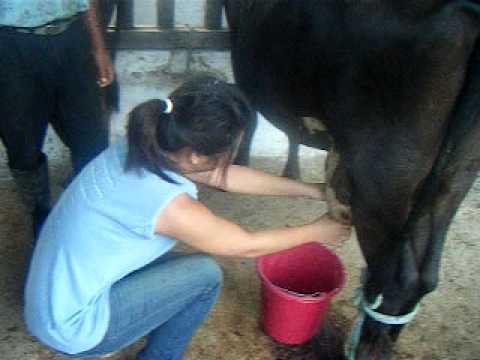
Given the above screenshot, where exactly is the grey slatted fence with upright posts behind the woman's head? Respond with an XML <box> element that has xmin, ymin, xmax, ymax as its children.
<box><xmin>99</xmin><ymin>0</ymin><xmax>229</xmax><ymax>50</ymax></box>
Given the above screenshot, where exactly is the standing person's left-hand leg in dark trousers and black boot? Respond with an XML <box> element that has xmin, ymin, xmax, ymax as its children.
<box><xmin>0</xmin><ymin>30</ymin><xmax>50</xmax><ymax>236</ymax></box>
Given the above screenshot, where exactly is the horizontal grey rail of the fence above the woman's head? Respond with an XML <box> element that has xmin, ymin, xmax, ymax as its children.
<box><xmin>107</xmin><ymin>28</ymin><xmax>230</xmax><ymax>50</ymax></box>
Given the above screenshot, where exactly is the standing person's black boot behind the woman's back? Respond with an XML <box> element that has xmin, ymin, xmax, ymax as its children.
<box><xmin>10</xmin><ymin>156</ymin><xmax>50</xmax><ymax>239</ymax></box>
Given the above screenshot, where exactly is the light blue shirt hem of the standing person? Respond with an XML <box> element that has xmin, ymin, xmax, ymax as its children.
<box><xmin>0</xmin><ymin>0</ymin><xmax>89</xmax><ymax>27</ymax></box>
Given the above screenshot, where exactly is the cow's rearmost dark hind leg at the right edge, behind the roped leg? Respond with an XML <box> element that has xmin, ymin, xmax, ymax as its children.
<box><xmin>391</xmin><ymin>35</ymin><xmax>480</xmax><ymax>339</ymax></box>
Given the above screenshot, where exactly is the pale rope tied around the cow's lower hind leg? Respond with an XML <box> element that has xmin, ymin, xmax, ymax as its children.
<box><xmin>345</xmin><ymin>288</ymin><xmax>420</xmax><ymax>360</ymax></box>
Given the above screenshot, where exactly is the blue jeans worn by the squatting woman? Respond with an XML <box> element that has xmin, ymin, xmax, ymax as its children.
<box><xmin>74</xmin><ymin>252</ymin><xmax>222</xmax><ymax>360</ymax></box>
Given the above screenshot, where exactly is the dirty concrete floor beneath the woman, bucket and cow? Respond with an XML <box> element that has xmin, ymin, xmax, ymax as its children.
<box><xmin>0</xmin><ymin>144</ymin><xmax>480</xmax><ymax>360</ymax></box>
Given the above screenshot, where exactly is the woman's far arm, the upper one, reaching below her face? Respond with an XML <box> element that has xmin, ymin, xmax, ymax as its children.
<box><xmin>185</xmin><ymin>165</ymin><xmax>325</xmax><ymax>200</ymax></box>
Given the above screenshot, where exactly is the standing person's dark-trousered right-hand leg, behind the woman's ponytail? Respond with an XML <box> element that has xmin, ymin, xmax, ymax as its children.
<box><xmin>51</xmin><ymin>19</ymin><xmax>109</xmax><ymax>174</ymax></box>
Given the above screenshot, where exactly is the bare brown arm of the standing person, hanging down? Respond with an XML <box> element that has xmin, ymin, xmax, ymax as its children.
<box><xmin>85</xmin><ymin>0</ymin><xmax>115</xmax><ymax>87</ymax></box>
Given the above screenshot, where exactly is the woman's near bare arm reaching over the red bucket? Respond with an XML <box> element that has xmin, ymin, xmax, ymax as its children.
<box><xmin>155</xmin><ymin>194</ymin><xmax>350</xmax><ymax>257</ymax></box>
